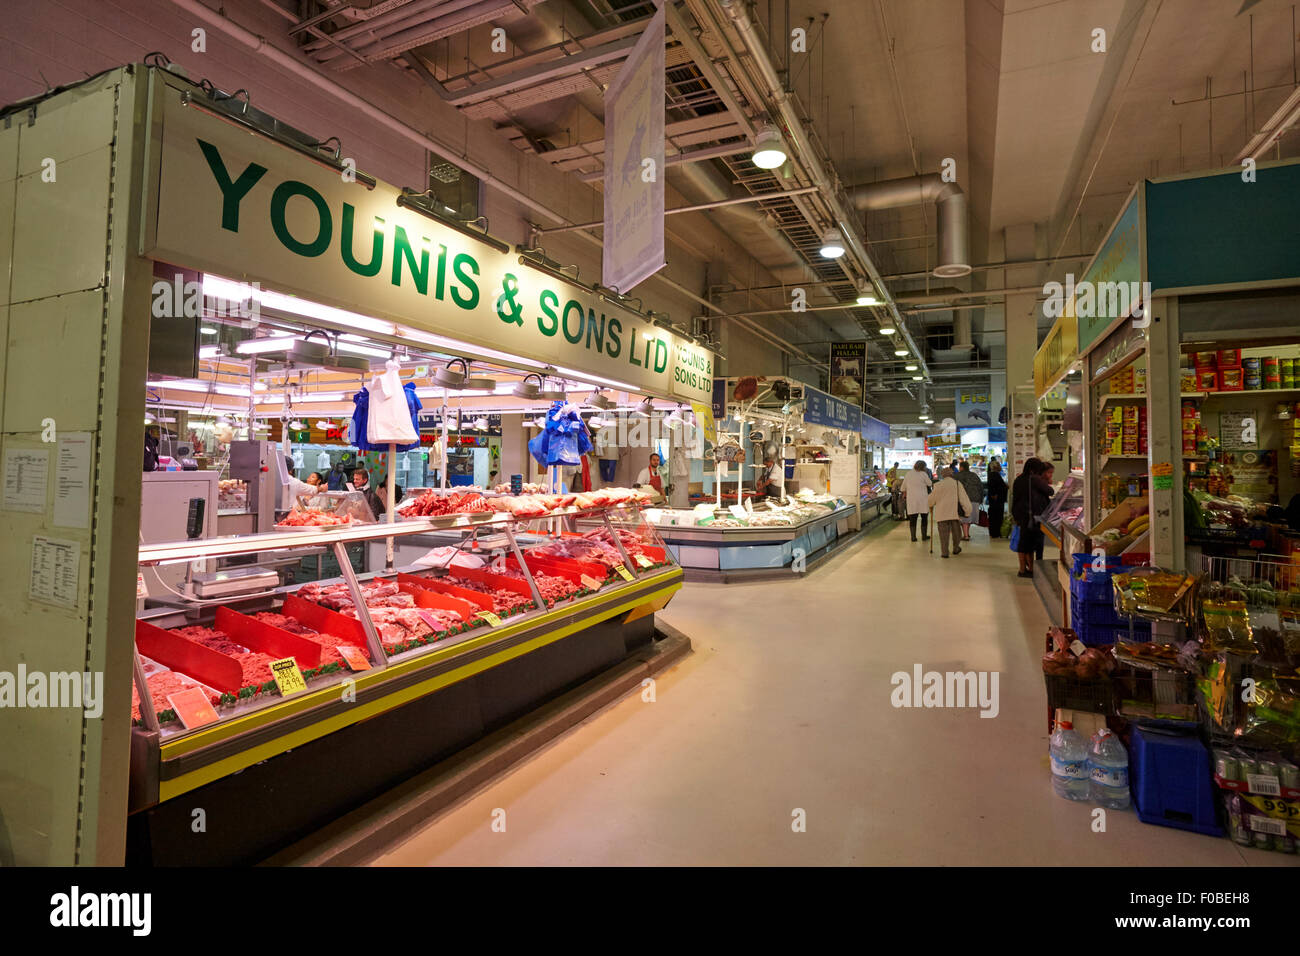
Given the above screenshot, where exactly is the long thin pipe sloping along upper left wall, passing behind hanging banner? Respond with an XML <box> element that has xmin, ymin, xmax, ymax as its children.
<box><xmin>172</xmin><ymin>0</ymin><xmax>824</xmax><ymax>364</ymax></box>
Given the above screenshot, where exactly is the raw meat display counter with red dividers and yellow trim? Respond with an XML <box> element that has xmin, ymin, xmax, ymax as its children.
<box><xmin>127</xmin><ymin>501</ymin><xmax>683</xmax><ymax>865</ymax></box>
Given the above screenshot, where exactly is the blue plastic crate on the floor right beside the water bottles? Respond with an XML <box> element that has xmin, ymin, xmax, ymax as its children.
<box><xmin>1128</xmin><ymin>727</ymin><xmax>1223</xmax><ymax>836</ymax></box>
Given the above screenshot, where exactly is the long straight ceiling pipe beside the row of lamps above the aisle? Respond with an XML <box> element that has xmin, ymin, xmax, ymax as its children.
<box><xmin>716</xmin><ymin>0</ymin><xmax>928</xmax><ymax>375</ymax></box>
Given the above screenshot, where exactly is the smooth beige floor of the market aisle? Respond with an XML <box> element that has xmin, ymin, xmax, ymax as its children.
<box><xmin>376</xmin><ymin>523</ymin><xmax>1294</xmax><ymax>866</ymax></box>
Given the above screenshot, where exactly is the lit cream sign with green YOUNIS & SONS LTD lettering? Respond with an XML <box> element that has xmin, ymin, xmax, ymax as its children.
<box><xmin>140</xmin><ymin>83</ymin><xmax>714</xmax><ymax>402</ymax></box>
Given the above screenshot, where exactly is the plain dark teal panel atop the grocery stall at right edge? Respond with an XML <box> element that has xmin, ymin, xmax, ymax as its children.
<box><xmin>1147</xmin><ymin>164</ymin><xmax>1300</xmax><ymax>293</ymax></box>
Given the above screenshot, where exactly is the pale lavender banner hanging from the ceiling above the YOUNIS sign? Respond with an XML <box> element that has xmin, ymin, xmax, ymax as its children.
<box><xmin>601</xmin><ymin>9</ymin><xmax>667</xmax><ymax>294</ymax></box>
